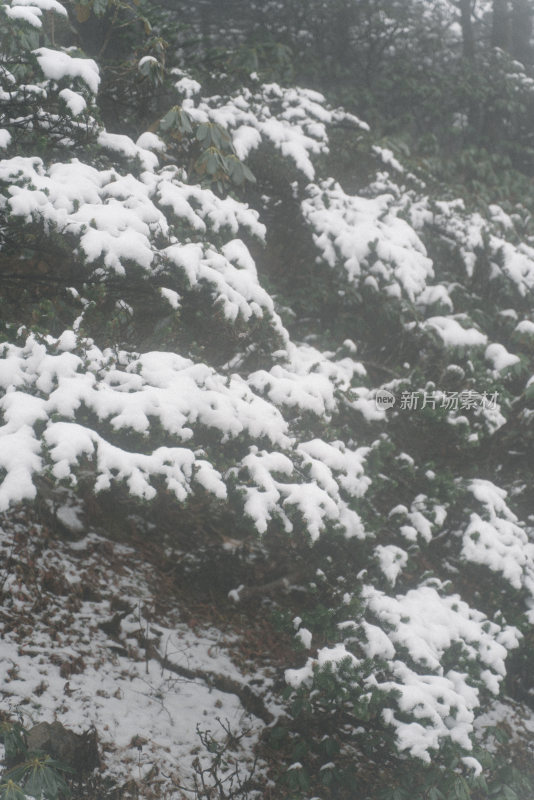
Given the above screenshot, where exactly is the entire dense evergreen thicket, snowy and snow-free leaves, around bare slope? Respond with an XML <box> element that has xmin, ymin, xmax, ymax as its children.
<box><xmin>0</xmin><ymin>0</ymin><xmax>534</xmax><ymax>800</ymax></box>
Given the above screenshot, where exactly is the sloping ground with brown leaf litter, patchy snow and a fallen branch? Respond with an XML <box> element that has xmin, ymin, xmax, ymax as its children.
<box><xmin>0</xmin><ymin>504</ymin><xmax>296</xmax><ymax>798</ymax></box>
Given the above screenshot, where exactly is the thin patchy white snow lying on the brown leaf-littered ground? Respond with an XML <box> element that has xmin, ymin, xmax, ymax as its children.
<box><xmin>0</xmin><ymin>523</ymin><xmax>275</xmax><ymax>791</ymax></box>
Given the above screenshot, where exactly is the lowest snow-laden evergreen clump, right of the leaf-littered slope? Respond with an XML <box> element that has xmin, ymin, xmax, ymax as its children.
<box><xmin>292</xmin><ymin>585</ymin><xmax>518</xmax><ymax>762</ymax></box>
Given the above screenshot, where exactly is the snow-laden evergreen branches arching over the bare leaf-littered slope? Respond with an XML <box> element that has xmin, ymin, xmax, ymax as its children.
<box><xmin>0</xmin><ymin>0</ymin><xmax>534</xmax><ymax>792</ymax></box>
